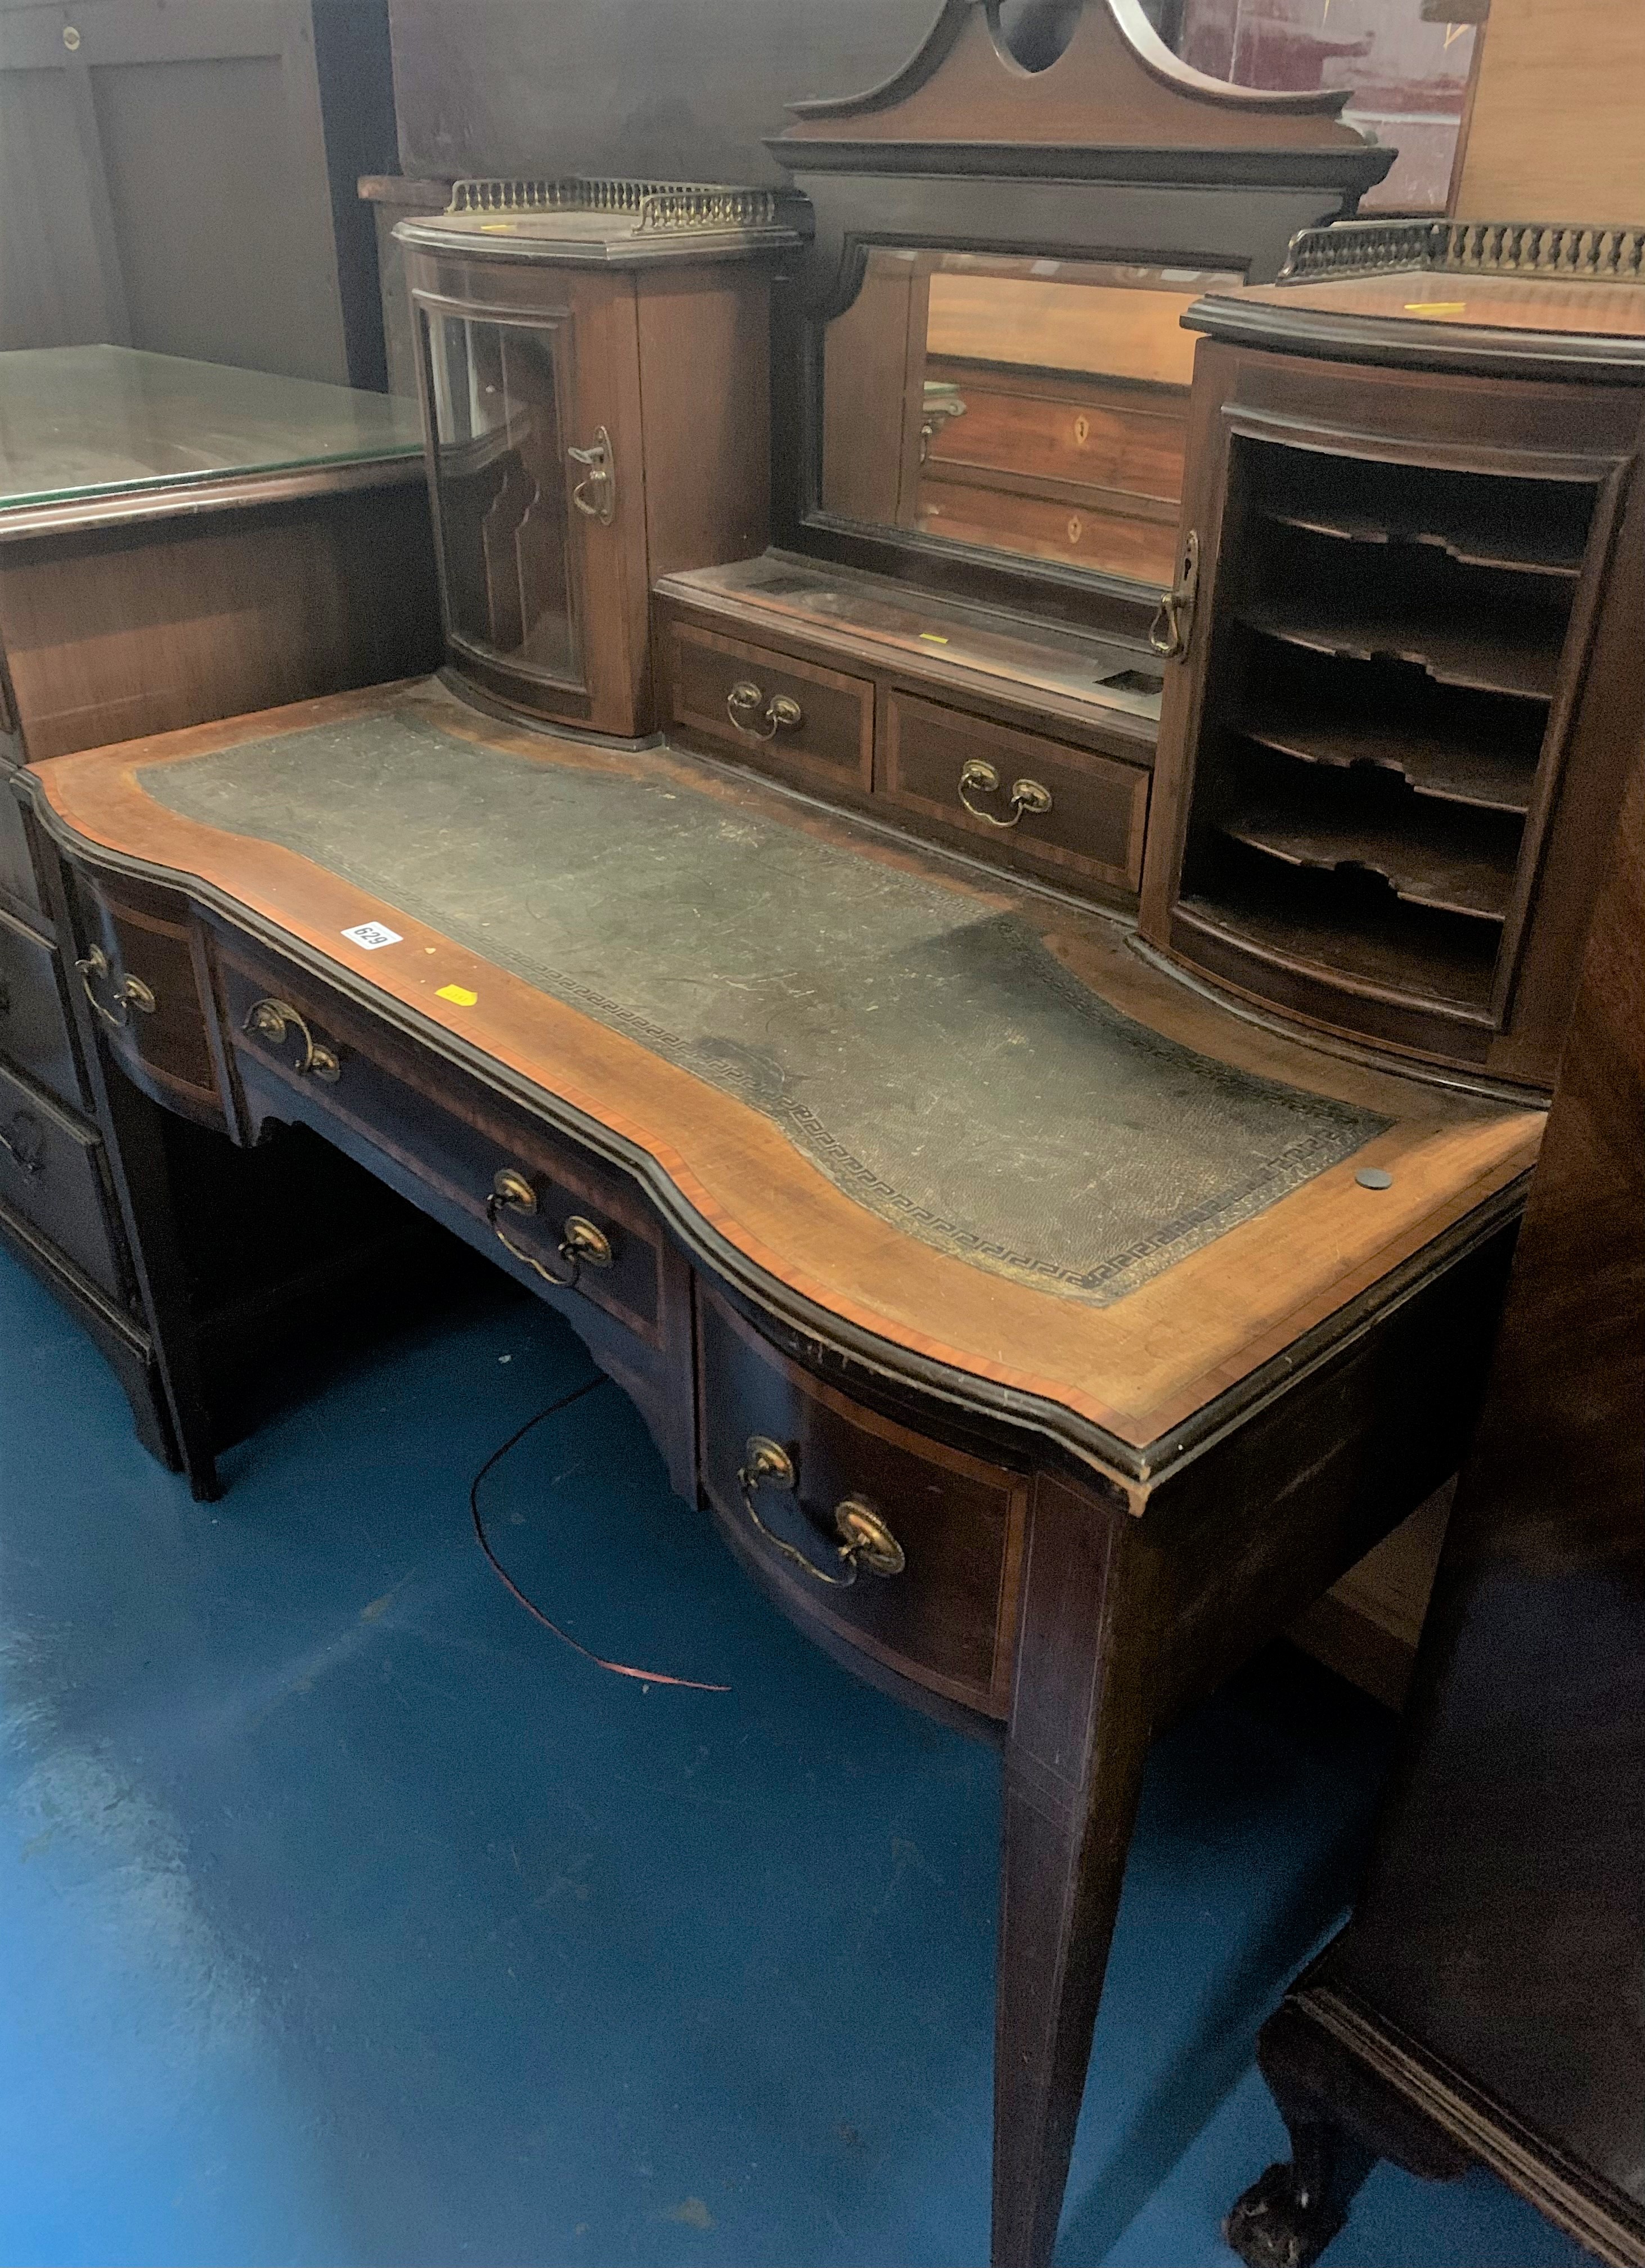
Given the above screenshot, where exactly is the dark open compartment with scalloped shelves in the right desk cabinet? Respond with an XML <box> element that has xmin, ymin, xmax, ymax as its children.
<box><xmin>1157</xmin><ymin>421</ymin><xmax>1597</xmax><ymax>1052</ymax></box>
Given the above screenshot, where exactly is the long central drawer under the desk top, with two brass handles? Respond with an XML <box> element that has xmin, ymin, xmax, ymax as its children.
<box><xmin>218</xmin><ymin>941</ymin><xmax>665</xmax><ymax>1347</ymax></box>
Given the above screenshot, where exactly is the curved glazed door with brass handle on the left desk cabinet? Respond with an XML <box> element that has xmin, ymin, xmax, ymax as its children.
<box><xmin>413</xmin><ymin>263</ymin><xmax>649</xmax><ymax>735</ymax></box>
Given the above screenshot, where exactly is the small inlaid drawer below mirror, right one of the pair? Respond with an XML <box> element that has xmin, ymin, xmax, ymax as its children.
<box><xmin>876</xmin><ymin>687</ymin><xmax>1150</xmax><ymax>891</ymax></box>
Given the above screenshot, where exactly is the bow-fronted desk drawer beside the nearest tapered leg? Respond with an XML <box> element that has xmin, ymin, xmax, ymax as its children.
<box><xmin>699</xmin><ymin>1286</ymin><xmax>1028</xmax><ymax>1717</ymax></box>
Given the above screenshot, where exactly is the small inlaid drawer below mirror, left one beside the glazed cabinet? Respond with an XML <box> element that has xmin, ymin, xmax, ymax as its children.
<box><xmin>665</xmin><ymin>621</ymin><xmax>874</xmax><ymax>796</ymax></box>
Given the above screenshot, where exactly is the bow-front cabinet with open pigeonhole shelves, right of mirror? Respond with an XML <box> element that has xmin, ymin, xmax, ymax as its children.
<box><xmin>1141</xmin><ymin>222</ymin><xmax>1645</xmax><ymax>1089</ymax></box>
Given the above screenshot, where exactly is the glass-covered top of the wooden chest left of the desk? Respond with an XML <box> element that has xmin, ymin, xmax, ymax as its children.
<box><xmin>0</xmin><ymin>347</ymin><xmax>422</xmax><ymax>542</ymax></box>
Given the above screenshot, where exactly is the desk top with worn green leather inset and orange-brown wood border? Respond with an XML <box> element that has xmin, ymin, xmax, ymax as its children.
<box><xmin>29</xmin><ymin>685</ymin><xmax>1543</xmax><ymax>1479</ymax></box>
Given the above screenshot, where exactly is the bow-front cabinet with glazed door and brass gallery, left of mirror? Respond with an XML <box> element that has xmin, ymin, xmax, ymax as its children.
<box><xmin>395</xmin><ymin>181</ymin><xmax>797</xmax><ymax>737</ymax></box>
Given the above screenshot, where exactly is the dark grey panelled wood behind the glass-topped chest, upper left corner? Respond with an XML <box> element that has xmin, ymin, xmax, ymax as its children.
<box><xmin>0</xmin><ymin>0</ymin><xmax>395</xmax><ymax>385</ymax></box>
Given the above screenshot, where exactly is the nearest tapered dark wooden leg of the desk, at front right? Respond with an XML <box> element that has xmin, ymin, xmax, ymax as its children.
<box><xmin>994</xmin><ymin>1479</ymin><xmax>1148</xmax><ymax>2268</ymax></box>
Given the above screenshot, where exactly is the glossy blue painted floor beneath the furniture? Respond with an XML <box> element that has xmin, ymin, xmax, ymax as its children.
<box><xmin>0</xmin><ymin>1256</ymin><xmax>1579</xmax><ymax>2268</ymax></box>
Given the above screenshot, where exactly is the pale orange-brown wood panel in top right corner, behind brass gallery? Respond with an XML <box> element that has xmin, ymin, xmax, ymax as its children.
<box><xmin>1457</xmin><ymin>0</ymin><xmax>1645</xmax><ymax>224</ymax></box>
